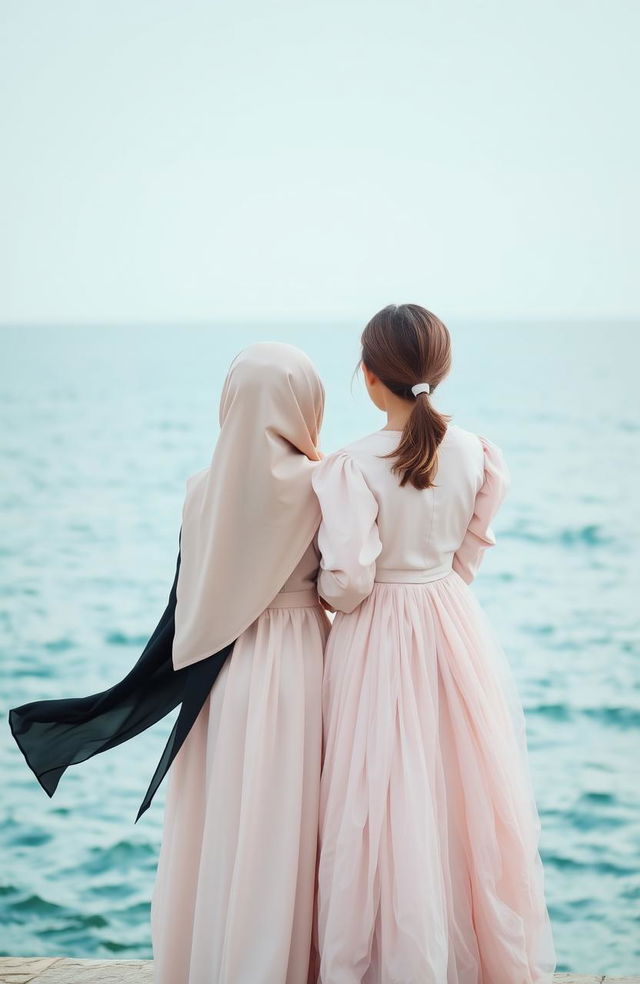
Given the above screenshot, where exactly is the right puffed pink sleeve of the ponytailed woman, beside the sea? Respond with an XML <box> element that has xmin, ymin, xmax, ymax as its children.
<box><xmin>453</xmin><ymin>437</ymin><xmax>510</xmax><ymax>584</ymax></box>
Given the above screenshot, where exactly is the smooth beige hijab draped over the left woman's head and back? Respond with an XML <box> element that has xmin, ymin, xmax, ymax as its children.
<box><xmin>173</xmin><ymin>342</ymin><xmax>324</xmax><ymax>669</ymax></box>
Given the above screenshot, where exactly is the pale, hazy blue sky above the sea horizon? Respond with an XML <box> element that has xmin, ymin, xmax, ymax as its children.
<box><xmin>0</xmin><ymin>0</ymin><xmax>640</xmax><ymax>325</ymax></box>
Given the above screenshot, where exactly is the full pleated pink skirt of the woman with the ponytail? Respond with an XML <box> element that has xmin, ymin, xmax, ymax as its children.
<box><xmin>316</xmin><ymin>573</ymin><xmax>555</xmax><ymax>984</ymax></box>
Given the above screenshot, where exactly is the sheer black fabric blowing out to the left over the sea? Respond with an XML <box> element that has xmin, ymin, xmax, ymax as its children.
<box><xmin>9</xmin><ymin>552</ymin><xmax>233</xmax><ymax>822</ymax></box>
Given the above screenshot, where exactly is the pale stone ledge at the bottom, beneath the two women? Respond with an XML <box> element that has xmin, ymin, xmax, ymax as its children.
<box><xmin>0</xmin><ymin>957</ymin><xmax>640</xmax><ymax>984</ymax></box>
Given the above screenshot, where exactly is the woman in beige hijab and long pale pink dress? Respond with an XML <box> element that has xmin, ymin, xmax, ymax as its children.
<box><xmin>151</xmin><ymin>344</ymin><xmax>328</xmax><ymax>984</ymax></box>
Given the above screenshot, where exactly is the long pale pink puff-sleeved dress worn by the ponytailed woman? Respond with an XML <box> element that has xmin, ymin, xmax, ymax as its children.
<box><xmin>314</xmin><ymin>426</ymin><xmax>555</xmax><ymax>984</ymax></box>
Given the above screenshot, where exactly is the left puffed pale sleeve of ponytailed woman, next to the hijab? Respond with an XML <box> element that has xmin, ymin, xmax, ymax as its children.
<box><xmin>313</xmin><ymin>452</ymin><xmax>382</xmax><ymax>612</ymax></box>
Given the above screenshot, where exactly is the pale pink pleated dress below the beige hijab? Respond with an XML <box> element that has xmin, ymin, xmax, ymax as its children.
<box><xmin>151</xmin><ymin>546</ymin><xmax>329</xmax><ymax>984</ymax></box>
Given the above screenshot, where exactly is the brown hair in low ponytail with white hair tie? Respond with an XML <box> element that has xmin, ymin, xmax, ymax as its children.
<box><xmin>361</xmin><ymin>304</ymin><xmax>451</xmax><ymax>489</ymax></box>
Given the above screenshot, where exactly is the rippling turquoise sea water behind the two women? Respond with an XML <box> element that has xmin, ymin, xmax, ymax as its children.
<box><xmin>0</xmin><ymin>324</ymin><xmax>640</xmax><ymax>974</ymax></box>
